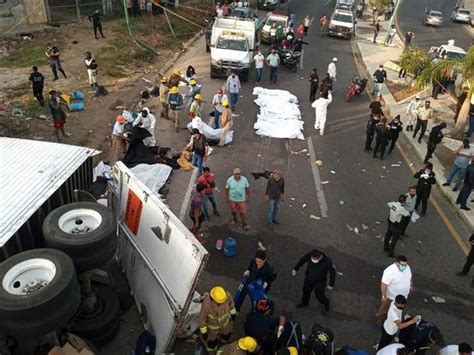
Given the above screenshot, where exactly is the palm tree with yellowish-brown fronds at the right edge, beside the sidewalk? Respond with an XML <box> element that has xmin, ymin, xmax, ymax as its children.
<box><xmin>416</xmin><ymin>46</ymin><xmax>474</xmax><ymax>134</ymax></box>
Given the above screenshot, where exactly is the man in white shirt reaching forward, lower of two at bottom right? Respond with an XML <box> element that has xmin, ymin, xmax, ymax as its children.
<box><xmin>377</xmin><ymin>295</ymin><xmax>421</xmax><ymax>349</ymax></box>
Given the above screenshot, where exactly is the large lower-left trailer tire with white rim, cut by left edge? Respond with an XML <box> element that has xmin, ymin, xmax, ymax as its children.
<box><xmin>0</xmin><ymin>249</ymin><xmax>81</xmax><ymax>341</ymax></box>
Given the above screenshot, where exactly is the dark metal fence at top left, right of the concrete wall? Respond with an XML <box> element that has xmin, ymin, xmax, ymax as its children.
<box><xmin>45</xmin><ymin>0</ymin><xmax>112</xmax><ymax>23</ymax></box>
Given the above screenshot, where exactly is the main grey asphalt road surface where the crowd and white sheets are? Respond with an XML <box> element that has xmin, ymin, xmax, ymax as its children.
<box><xmin>104</xmin><ymin>0</ymin><xmax>474</xmax><ymax>354</ymax></box>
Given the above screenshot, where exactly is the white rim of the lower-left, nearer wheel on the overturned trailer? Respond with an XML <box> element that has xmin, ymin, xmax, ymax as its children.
<box><xmin>2</xmin><ymin>258</ymin><xmax>56</xmax><ymax>296</ymax></box>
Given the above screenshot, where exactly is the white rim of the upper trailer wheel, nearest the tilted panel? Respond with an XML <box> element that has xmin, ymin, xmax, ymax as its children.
<box><xmin>58</xmin><ymin>208</ymin><xmax>102</xmax><ymax>234</ymax></box>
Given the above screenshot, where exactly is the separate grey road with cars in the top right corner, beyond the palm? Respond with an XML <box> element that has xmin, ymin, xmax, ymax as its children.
<box><xmin>397</xmin><ymin>0</ymin><xmax>474</xmax><ymax>50</ymax></box>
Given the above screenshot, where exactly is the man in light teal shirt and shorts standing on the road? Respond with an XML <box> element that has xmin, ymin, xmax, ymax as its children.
<box><xmin>225</xmin><ymin>168</ymin><xmax>250</xmax><ymax>230</ymax></box>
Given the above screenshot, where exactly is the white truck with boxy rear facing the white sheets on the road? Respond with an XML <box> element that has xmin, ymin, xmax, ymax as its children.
<box><xmin>210</xmin><ymin>17</ymin><xmax>256</xmax><ymax>82</ymax></box>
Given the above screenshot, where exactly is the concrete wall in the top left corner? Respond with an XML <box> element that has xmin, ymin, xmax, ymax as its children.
<box><xmin>0</xmin><ymin>0</ymin><xmax>47</xmax><ymax>30</ymax></box>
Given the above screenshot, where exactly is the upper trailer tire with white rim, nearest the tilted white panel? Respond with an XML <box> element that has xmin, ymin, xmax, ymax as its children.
<box><xmin>43</xmin><ymin>202</ymin><xmax>117</xmax><ymax>271</ymax></box>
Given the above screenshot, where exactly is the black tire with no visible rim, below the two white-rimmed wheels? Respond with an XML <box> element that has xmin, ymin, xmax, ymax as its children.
<box><xmin>71</xmin><ymin>286</ymin><xmax>120</xmax><ymax>346</ymax></box>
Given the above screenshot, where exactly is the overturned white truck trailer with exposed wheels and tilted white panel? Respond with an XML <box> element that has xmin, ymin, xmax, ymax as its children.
<box><xmin>0</xmin><ymin>138</ymin><xmax>208</xmax><ymax>354</ymax></box>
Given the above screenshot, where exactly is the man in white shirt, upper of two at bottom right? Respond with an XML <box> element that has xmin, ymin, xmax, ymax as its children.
<box><xmin>375</xmin><ymin>255</ymin><xmax>413</xmax><ymax>325</ymax></box>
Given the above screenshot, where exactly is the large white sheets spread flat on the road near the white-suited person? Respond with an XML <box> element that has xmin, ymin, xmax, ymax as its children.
<box><xmin>253</xmin><ymin>87</ymin><xmax>304</xmax><ymax>139</ymax></box>
